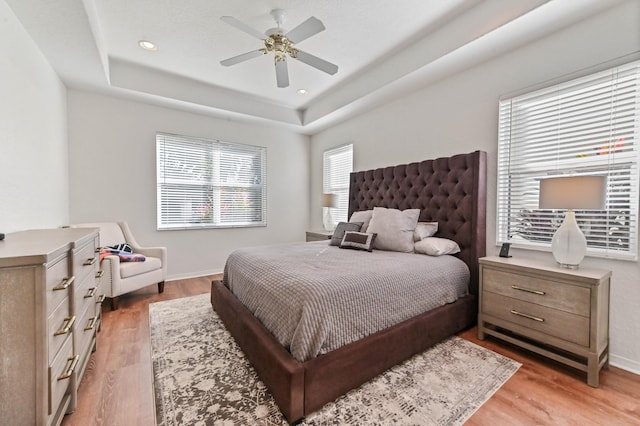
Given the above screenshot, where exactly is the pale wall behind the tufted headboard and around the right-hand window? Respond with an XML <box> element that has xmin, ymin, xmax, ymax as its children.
<box><xmin>311</xmin><ymin>1</ymin><xmax>640</xmax><ymax>373</ymax></box>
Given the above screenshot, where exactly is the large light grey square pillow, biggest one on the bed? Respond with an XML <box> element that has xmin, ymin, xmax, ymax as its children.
<box><xmin>367</xmin><ymin>207</ymin><xmax>420</xmax><ymax>253</ymax></box>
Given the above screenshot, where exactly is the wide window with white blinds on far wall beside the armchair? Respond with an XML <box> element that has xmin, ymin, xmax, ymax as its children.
<box><xmin>156</xmin><ymin>133</ymin><xmax>267</xmax><ymax>229</ymax></box>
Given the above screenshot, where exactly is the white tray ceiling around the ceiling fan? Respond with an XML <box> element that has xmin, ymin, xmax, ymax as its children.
<box><xmin>5</xmin><ymin>0</ymin><xmax>617</xmax><ymax>133</ymax></box>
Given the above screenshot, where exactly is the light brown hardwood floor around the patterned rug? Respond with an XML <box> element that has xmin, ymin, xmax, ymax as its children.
<box><xmin>62</xmin><ymin>276</ymin><xmax>640</xmax><ymax>426</ymax></box>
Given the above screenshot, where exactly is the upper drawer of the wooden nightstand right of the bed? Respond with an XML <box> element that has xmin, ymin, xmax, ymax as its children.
<box><xmin>482</xmin><ymin>267</ymin><xmax>591</xmax><ymax>317</ymax></box>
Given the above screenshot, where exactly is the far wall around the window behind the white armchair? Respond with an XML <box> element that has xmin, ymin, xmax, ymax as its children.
<box><xmin>68</xmin><ymin>90</ymin><xmax>309</xmax><ymax>279</ymax></box>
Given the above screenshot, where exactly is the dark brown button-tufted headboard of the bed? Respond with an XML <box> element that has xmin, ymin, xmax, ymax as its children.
<box><xmin>349</xmin><ymin>151</ymin><xmax>487</xmax><ymax>296</ymax></box>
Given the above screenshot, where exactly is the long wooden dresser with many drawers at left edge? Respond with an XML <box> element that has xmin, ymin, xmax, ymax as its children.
<box><xmin>0</xmin><ymin>228</ymin><xmax>104</xmax><ymax>425</ymax></box>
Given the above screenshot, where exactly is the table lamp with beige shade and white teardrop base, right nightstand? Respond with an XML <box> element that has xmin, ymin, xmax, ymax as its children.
<box><xmin>539</xmin><ymin>176</ymin><xmax>607</xmax><ymax>269</ymax></box>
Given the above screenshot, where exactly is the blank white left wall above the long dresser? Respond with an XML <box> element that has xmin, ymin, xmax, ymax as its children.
<box><xmin>0</xmin><ymin>0</ymin><xmax>69</xmax><ymax>233</ymax></box>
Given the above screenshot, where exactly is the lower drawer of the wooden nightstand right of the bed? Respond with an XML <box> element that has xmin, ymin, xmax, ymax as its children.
<box><xmin>481</xmin><ymin>291</ymin><xmax>589</xmax><ymax>347</ymax></box>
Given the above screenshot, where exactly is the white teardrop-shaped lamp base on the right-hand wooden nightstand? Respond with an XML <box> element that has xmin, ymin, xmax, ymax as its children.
<box><xmin>551</xmin><ymin>210</ymin><xmax>587</xmax><ymax>269</ymax></box>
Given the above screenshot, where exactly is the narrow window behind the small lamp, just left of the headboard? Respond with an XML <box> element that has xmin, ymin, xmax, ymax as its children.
<box><xmin>322</xmin><ymin>144</ymin><xmax>353</xmax><ymax>229</ymax></box>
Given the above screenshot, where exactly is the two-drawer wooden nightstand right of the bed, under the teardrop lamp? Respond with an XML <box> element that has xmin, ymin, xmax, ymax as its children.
<box><xmin>478</xmin><ymin>257</ymin><xmax>611</xmax><ymax>387</ymax></box>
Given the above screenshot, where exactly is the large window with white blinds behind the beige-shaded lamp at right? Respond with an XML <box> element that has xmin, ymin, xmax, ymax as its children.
<box><xmin>497</xmin><ymin>61</ymin><xmax>640</xmax><ymax>259</ymax></box>
